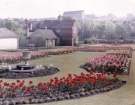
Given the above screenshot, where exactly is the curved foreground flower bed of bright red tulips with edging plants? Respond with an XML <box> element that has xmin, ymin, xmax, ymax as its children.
<box><xmin>0</xmin><ymin>72</ymin><xmax>125</xmax><ymax>105</ymax></box>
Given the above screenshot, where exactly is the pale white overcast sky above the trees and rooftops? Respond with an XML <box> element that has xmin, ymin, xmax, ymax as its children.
<box><xmin>0</xmin><ymin>0</ymin><xmax>135</xmax><ymax>18</ymax></box>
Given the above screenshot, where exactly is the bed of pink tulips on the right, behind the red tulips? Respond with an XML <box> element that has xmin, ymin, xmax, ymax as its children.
<box><xmin>81</xmin><ymin>53</ymin><xmax>130</xmax><ymax>74</ymax></box>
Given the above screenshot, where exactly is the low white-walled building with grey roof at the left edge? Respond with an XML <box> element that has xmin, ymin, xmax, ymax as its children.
<box><xmin>0</xmin><ymin>28</ymin><xmax>18</xmax><ymax>50</ymax></box>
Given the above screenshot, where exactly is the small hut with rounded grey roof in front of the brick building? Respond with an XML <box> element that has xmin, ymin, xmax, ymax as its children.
<box><xmin>29</xmin><ymin>29</ymin><xmax>59</xmax><ymax>48</ymax></box>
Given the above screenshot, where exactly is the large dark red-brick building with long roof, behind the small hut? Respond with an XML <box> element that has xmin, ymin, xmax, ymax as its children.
<box><xmin>29</xmin><ymin>18</ymin><xmax>78</xmax><ymax>46</ymax></box>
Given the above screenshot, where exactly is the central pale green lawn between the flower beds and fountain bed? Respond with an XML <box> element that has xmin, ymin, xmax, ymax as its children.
<box><xmin>0</xmin><ymin>52</ymin><xmax>104</xmax><ymax>83</ymax></box>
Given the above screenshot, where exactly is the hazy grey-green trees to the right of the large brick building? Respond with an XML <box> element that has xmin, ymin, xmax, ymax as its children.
<box><xmin>77</xmin><ymin>18</ymin><xmax>135</xmax><ymax>42</ymax></box>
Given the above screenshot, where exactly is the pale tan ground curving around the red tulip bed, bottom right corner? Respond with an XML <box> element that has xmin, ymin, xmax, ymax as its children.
<box><xmin>30</xmin><ymin>52</ymin><xmax>135</xmax><ymax>105</ymax></box>
